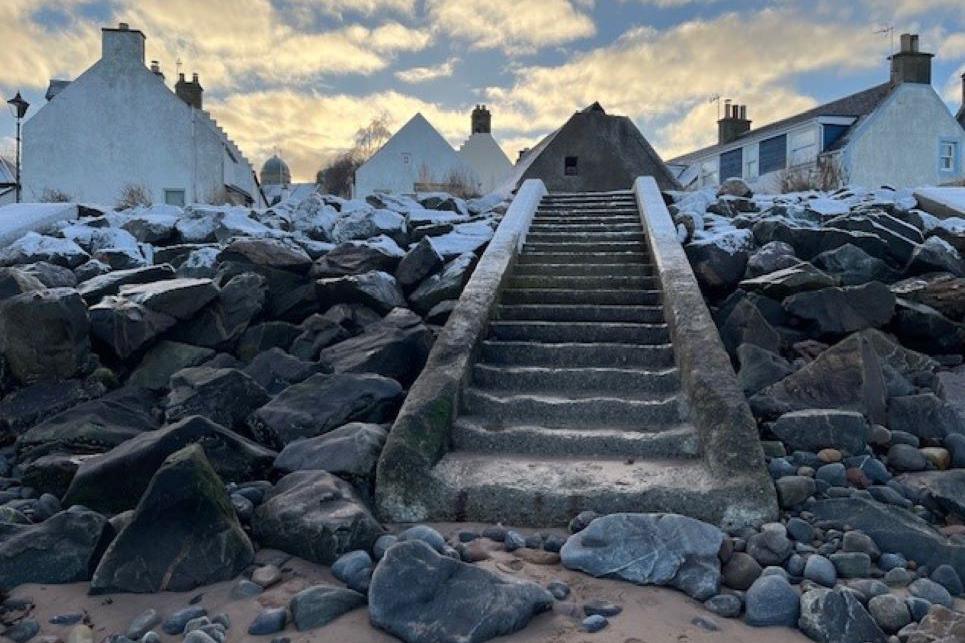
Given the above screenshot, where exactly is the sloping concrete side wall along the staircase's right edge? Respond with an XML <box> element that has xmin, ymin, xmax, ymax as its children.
<box><xmin>633</xmin><ymin>176</ymin><xmax>772</xmax><ymax>489</ymax></box>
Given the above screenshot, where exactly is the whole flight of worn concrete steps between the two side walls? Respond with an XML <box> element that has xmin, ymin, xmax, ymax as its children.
<box><xmin>433</xmin><ymin>192</ymin><xmax>734</xmax><ymax>525</ymax></box>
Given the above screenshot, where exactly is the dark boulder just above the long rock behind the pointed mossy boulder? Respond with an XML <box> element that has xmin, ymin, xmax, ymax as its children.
<box><xmin>17</xmin><ymin>387</ymin><xmax>158</xmax><ymax>460</ymax></box>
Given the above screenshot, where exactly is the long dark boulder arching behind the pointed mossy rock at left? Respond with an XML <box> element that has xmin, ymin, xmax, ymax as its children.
<box><xmin>63</xmin><ymin>416</ymin><xmax>276</xmax><ymax>514</ymax></box>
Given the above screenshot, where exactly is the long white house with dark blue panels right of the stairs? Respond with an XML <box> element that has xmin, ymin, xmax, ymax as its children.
<box><xmin>667</xmin><ymin>34</ymin><xmax>965</xmax><ymax>191</ymax></box>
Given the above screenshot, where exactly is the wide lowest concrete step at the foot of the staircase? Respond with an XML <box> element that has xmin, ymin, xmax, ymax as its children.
<box><xmin>432</xmin><ymin>451</ymin><xmax>754</xmax><ymax>526</ymax></box>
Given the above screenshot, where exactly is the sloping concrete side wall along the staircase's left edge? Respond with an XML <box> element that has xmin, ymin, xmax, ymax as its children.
<box><xmin>375</xmin><ymin>179</ymin><xmax>546</xmax><ymax>522</ymax></box>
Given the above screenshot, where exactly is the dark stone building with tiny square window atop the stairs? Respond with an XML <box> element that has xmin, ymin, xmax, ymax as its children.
<box><xmin>514</xmin><ymin>103</ymin><xmax>680</xmax><ymax>192</ymax></box>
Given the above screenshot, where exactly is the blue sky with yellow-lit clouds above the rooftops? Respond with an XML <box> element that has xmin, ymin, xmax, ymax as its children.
<box><xmin>0</xmin><ymin>0</ymin><xmax>965</xmax><ymax>180</ymax></box>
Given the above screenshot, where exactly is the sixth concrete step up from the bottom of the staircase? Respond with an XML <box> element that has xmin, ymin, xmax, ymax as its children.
<box><xmin>489</xmin><ymin>321</ymin><xmax>670</xmax><ymax>345</ymax></box>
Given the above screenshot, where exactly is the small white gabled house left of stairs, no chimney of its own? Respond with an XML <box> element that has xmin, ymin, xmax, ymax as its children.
<box><xmin>352</xmin><ymin>114</ymin><xmax>479</xmax><ymax>199</ymax></box>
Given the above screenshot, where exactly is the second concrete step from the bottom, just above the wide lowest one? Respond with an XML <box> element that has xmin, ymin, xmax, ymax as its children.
<box><xmin>452</xmin><ymin>415</ymin><xmax>700</xmax><ymax>458</ymax></box>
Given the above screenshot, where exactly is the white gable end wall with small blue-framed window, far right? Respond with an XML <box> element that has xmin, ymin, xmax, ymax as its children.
<box><xmin>844</xmin><ymin>83</ymin><xmax>965</xmax><ymax>188</ymax></box>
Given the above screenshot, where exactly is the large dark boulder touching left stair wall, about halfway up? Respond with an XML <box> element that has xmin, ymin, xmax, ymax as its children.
<box><xmin>319</xmin><ymin>308</ymin><xmax>433</xmax><ymax>386</ymax></box>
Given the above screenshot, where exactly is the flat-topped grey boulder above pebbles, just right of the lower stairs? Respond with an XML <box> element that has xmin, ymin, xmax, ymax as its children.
<box><xmin>771</xmin><ymin>409</ymin><xmax>870</xmax><ymax>455</ymax></box>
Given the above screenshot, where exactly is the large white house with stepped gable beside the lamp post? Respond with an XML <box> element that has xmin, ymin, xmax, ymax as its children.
<box><xmin>22</xmin><ymin>23</ymin><xmax>264</xmax><ymax>206</ymax></box>
